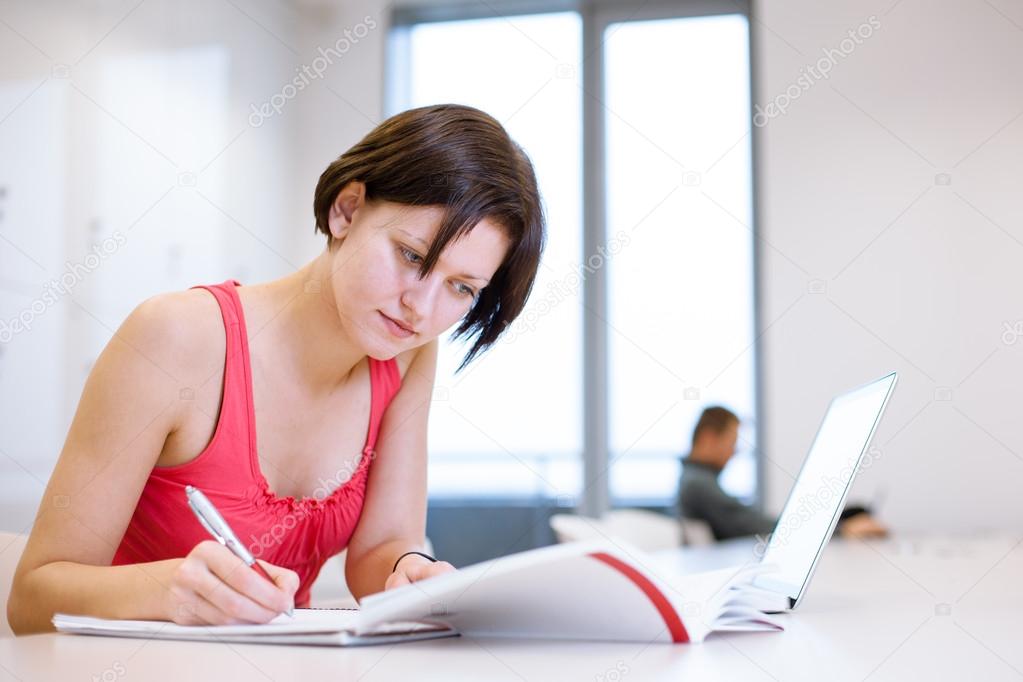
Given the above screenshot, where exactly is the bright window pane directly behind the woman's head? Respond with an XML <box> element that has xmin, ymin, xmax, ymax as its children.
<box><xmin>389</xmin><ymin>12</ymin><xmax>582</xmax><ymax>497</ymax></box>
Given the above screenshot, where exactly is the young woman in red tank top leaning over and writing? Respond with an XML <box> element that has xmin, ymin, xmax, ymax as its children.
<box><xmin>7</xmin><ymin>105</ymin><xmax>544</xmax><ymax>634</ymax></box>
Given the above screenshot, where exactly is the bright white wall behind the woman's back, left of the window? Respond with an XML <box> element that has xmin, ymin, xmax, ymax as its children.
<box><xmin>0</xmin><ymin>1</ymin><xmax>311</xmax><ymax>531</ymax></box>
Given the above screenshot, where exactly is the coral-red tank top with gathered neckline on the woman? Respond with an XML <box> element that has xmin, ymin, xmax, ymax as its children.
<box><xmin>112</xmin><ymin>279</ymin><xmax>401</xmax><ymax>606</ymax></box>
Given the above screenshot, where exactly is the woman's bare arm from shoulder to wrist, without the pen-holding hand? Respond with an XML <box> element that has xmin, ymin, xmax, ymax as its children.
<box><xmin>7</xmin><ymin>298</ymin><xmax>188</xmax><ymax>633</ymax></box>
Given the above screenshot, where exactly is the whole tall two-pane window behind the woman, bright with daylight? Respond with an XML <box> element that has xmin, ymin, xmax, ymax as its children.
<box><xmin>387</xmin><ymin>2</ymin><xmax>756</xmax><ymax>512</ymax></box>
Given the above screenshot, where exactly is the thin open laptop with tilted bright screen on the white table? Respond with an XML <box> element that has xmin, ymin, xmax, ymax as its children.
<box><xmin>754</xmin><ymin>372</ymin><xmax>898</xmax><ymax>609</ymax></box>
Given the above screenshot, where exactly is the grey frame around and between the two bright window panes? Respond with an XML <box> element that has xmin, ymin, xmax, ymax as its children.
<box><xmin>383</xmin><ymin>0</ymin><xmax>765</xmax><ymax>516</ymax></box>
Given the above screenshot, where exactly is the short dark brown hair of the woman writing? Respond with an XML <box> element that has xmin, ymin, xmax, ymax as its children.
<box><xmin>313</xmin><ymin>104</ymin><xmax>546</xmax><ymax>370</ymax></box>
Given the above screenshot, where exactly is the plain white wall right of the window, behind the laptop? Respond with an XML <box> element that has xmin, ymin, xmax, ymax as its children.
<box><xmin>755</xmin><ymin>0</ymin><xmax>1023</xmax><ymax>531</ymax></box>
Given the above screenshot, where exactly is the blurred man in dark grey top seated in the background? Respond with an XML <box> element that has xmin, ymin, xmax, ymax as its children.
<box><xmin>678</xmin><ymin>407</ymin><xmax>887</xmax><ymax>540</ymax></box>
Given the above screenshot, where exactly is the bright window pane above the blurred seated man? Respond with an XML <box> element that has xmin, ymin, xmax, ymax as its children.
<box><xmin>604</xmin><ymin>14</ymin><xmax>755</xmax><ymax>503</ymax></box>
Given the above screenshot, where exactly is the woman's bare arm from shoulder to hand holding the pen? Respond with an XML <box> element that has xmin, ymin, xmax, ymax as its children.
<box><xmin>7</xmin><ymin>292</ymin><xmax>298</xmax><ymax>634</ymax></box>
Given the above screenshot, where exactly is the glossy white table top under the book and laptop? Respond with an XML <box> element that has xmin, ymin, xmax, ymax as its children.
<box><xmin>0</xmin><ymin>535</ymin><xmax>1023</xmax><ymax>682</ymax></box>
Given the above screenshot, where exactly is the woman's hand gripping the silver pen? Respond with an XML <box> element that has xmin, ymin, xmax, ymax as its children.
<box><xmin>159</xmin><ymin>540</ymin><xmax>299</xmax><ymax>625</ymax></box>
